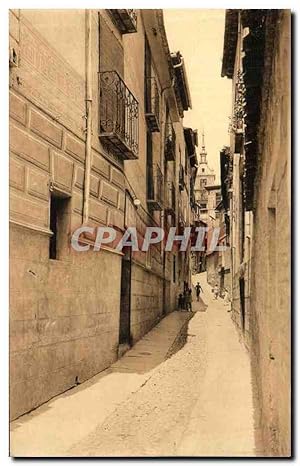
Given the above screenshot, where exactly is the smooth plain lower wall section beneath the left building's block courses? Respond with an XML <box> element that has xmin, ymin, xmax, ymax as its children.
<box><xmin>10</xmin><ymin>226</ymin><xmax>121</xmax><ymax>419</ymax></box>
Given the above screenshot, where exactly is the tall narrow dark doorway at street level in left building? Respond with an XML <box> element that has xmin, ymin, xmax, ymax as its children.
<box><xmin>119</xmin><ymin>248</ymin><xmax>131</xmax><ymax>345</ymax></box>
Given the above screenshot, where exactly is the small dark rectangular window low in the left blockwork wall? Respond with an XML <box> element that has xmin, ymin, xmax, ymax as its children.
<box><xmin>49</xmin><ymin>193</ymin><xmax>70</xmax><ymax>260</ymax></box>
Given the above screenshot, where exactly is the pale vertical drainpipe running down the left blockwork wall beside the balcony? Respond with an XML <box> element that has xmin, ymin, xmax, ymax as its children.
<box><xmin>83</xmin><ymin>10</ymin><xmax>92</xmax><ymax>223</ymax></box>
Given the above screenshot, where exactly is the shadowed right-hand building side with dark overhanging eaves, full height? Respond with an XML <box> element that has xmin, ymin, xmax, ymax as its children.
<box><xmin>222</xmin><ymin>10</ymin><xmax>291</xmax><ymax>456</ymax></box>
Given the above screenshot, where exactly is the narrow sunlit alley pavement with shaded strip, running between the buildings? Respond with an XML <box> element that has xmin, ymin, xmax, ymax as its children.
<box><xmin>11</xmin><ymin>274</ymin><xmax>257</xmax><ymax>457</ymax></box>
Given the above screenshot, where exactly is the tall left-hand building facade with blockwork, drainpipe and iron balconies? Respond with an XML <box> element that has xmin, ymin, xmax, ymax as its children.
<box><xmin>9</xmin><ymin>10</ymin><xmax>194</xmax><ymax>419</ymax></box>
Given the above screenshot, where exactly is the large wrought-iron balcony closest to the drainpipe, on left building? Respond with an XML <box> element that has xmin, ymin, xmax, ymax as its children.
<box><xmin>99</xmin><ymin>71</ymin><xmax>139</xmax><ymax>160</ymax></box>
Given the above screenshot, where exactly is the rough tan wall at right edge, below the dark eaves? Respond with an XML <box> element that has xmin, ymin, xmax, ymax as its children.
<box><xmin>250</xmin><ymin>10</ymin><xmax>291</xmax><ymax>456</ymax></box>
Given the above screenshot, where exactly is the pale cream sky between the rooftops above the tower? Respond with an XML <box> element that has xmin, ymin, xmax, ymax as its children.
<box><xmin>164</xmin><ymin>9</ymin><xmax>232</xmax><ymax>183</ymax></box>
